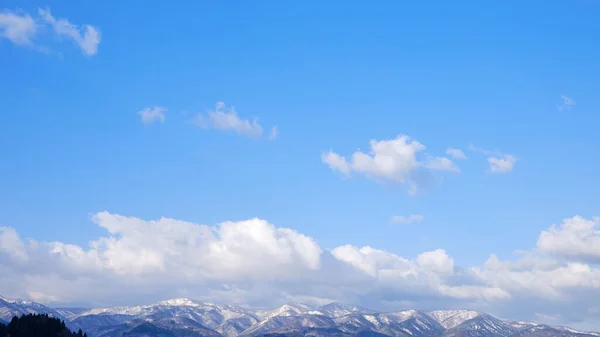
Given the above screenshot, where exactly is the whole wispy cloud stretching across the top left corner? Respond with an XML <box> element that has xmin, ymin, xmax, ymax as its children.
<box><xmin>0</xmin><ymin>8</ymin><xmax>101</xmax><ymax>56</ymax></box>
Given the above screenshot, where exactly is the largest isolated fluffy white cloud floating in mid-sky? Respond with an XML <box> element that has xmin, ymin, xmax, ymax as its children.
<box><xmin>321</xmin><ymin>135</ymin><xmax>459</xmax><ymax>190</ymax></box>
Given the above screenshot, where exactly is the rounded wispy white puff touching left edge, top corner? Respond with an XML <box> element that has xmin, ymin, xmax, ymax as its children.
<box><xmin>0</xmin><ymin>10</ymin><xmax>38</xmax><ymax>45</ymax></box>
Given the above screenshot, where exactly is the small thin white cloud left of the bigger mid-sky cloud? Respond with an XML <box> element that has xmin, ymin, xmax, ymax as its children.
<box><xmin>193</xmin><ymin>102</ymin><xmax>264</xmax><ymax>138</ymax></box>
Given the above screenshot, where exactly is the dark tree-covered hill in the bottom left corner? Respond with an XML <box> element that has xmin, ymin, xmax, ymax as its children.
<box><xmin>0</xmin><ymin>314</ymin><xmax>87</xmax><ymax>337</ymax></box>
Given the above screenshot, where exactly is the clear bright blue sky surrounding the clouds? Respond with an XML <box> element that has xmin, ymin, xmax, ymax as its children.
<box><xmin>0</xmin><ymin>0</ymin><xmax>600</xmax><ymax>330</ymax></box>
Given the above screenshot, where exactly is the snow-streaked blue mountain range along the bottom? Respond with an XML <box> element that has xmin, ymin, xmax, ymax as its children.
<box><xmin>0</xmin><ymin>297</ymin><xmax>600</xmax><ymax>337</ymax></box>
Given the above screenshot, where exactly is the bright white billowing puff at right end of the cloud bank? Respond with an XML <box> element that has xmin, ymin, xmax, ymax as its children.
<box><xmin>537</xmin><ymin>216</ymin><xmax>600</xmax><ymax>263</ymax></box>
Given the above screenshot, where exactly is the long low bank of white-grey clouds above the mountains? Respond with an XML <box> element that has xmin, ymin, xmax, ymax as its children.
<box><xmin>0</xmin><ymin>212</ymin><xmax>600</xmax><ymax>324</ymax></box>
